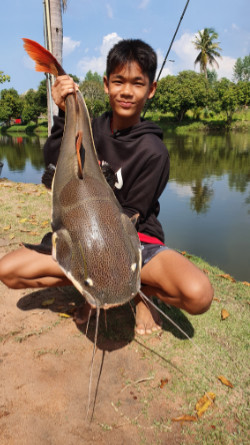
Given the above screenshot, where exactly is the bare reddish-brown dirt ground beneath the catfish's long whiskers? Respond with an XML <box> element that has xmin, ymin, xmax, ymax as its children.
<box><xmin>0</xmin><ymin>246</ymin><xmax>193</xmax><ymax>445</ymax></box>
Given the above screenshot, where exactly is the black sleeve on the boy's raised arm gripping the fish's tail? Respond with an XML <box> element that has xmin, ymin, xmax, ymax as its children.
<box><xmin>43</xmin><ymin>110</ymin><xmax>65</xmax><ymax>167</ymax></box>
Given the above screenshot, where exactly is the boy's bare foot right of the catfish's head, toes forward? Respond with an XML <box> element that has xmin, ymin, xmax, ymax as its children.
<box><xmin>135</xmin><ymin>297</ymin><xmax>162</xmax><ymax>335</ymax></box>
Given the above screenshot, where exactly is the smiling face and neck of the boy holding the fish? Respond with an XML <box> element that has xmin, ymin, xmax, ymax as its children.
<box><xmin>104</xmin><ymin>62</ymin><xmax>156</xmax><ymax>130</ymax></box>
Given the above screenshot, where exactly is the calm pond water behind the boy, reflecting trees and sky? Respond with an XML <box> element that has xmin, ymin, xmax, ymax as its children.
<box><xmin>0</xmin><ymin>133</ymin><xmax>250</xmax><ymax>281</ymax></box>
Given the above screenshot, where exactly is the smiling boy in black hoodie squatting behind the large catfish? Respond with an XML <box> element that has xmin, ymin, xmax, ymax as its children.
<box><xmin>0</xmin><ymin>40</ymin><xmax>213</xmax><ymax>335</ymax></box>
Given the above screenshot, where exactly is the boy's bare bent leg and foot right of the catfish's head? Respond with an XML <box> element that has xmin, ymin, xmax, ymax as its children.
<box><xmin>136</xmin><ymin>250</ymin><xmax>213</xmax><ymax>334</ymax></box>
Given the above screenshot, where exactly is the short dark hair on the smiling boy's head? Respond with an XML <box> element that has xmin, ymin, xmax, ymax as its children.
<box><xmin>106</xmin><ymin>39</ymin><xmax>157</xmax><ymax>83</ymax></box>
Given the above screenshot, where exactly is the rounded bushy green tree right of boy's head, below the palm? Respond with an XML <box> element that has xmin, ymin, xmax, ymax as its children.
<box><xmin>153</xmin><ymin>71</ymin><xmax>208</xmax><ymax>122</ymax></box>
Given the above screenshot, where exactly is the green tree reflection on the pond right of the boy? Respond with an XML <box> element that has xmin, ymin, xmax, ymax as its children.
<box><xmin>164</xmin><ymin>133</ymin><xmax>250</xmax><ymax>213</ymax></box>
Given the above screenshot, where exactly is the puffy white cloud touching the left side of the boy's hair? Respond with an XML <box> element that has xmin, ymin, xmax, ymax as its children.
<box><xmin>78</xmin><ymin>32</ymin><xmax>122</xmax><ymax>78</ymax></box>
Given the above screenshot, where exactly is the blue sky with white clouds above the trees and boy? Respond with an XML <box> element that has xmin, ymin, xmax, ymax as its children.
<box><xmin>0</xmin><ymin>0</ymin><xmax>250</xmax><ymax>93</ymax></box>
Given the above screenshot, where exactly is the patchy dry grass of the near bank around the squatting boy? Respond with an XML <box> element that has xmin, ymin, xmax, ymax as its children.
<box><xmin>0</xmin><ymin>180</ymin><xmax>250</xmax><ymax>445</ymax></box>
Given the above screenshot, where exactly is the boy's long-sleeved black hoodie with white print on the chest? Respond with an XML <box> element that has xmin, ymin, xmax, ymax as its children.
<box><xmin>44</xmin><ymin>113</ymin><xmax>169</xmax><ymax>241</ymax></box>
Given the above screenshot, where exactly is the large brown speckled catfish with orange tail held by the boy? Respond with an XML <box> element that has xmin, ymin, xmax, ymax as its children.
<box><xmin>23</xmin><ymin>39</ymin><xmax>141</xmax><ymax>309</ymax></box>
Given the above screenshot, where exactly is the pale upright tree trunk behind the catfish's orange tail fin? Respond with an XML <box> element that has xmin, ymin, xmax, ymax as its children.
<box><xmin>43</xmin><ymin>0</ymin><xmax>67</xmax><ymax>134</ymax></box>
